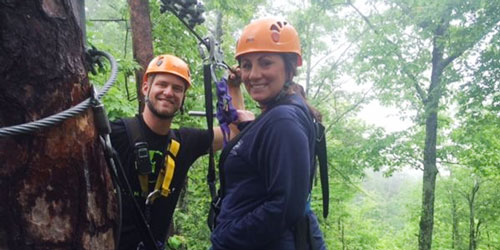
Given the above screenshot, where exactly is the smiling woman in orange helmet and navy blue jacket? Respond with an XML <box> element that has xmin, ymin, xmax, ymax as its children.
<box><xmin>211</xmin><ymin>18</ymin><xmax>326</xmax><ymax>250</ymax></box>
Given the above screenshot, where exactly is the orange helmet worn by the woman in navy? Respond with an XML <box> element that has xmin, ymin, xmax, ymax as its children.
<box><xmin>235</xmin><ymin>18</ymin><xmax>302</xmax><ymax>66</ymax></box>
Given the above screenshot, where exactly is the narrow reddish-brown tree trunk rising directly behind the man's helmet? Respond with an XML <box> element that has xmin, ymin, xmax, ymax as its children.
<box><xmin>128</xmin><ymin>0</ymin><xmax>153</xmax><ymax>113</ymax></box>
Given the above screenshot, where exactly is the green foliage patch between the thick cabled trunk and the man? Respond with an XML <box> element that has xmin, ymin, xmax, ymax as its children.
<box><xmin>86</xmin><ymin>0</ymin><xmax>139</xmax><ymax>120</ymax></box>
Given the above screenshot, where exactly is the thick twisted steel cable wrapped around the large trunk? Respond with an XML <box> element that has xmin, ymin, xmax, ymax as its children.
<box><xmin>0</xmin><ymin>50</ymin><xmax>118</xmax><ymax>138</ymax></box>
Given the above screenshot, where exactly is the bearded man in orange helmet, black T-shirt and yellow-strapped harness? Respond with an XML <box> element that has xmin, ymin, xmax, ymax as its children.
<box><xmin>111</xmin><ymin>55</ymin><xmax>248</xmax><ymax>250</ymax></box>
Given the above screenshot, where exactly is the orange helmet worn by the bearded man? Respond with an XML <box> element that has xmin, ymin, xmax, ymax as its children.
<box><xmin>144</xmin><ymin>54</ymin><xmax>191</xmax><ymax>89</ymax></box>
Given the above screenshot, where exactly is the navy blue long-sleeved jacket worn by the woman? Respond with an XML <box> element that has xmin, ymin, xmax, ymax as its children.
<box><xmin>211</xmin><ymin>95</ymin><xmax>315</xmax><ymax>250</ymax></box>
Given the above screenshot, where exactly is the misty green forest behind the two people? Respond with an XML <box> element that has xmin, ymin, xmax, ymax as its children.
<box><xmin>85</xmin><ymin>0</ymin><xmax>500</xmax><ymax>250</ymax></box>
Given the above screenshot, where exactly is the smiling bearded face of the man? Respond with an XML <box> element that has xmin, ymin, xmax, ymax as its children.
<box><xmin>142</xmin><ymin>73</ymin><xmax>186</xmax><ymax>119</ymax></box>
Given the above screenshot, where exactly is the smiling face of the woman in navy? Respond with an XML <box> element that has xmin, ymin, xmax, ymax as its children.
<box><xmin>240</xmin><ymin>53</ymin><xmax>287</xmax><ymax>107</ymax></box>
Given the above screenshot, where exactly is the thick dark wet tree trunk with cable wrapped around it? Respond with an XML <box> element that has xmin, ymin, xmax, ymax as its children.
<box><xmin>0</xmin><ymin>0</ymin><xmax>117</xmax><ymax>249</ymax></box>
